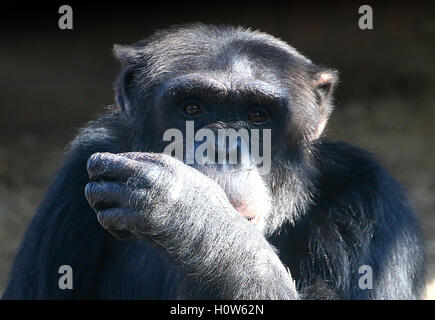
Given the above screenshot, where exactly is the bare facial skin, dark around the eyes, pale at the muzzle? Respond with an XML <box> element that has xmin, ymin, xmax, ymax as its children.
<box><xmin>153</xmin><ymin>68</ymin><xmax>290</xmax><ymax>227</ymax></box>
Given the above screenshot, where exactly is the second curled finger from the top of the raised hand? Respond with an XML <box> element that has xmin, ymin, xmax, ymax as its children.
<box><xmin>85</xmin><ymin>181</ymin><xmax>131</xmax><ymax>211</ymax></box>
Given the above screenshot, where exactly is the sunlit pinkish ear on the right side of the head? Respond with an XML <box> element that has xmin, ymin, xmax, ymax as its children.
<box><xmin>311</xmin><ymin>68</ymin><xmax>338</xmax><ymax>140</ymax></box>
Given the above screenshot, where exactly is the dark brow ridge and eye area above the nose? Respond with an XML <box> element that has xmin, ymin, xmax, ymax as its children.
<box><xmin>153</xmin><ymin>73</ymin><xmax>290</xmax><ymax>152</ymax></box>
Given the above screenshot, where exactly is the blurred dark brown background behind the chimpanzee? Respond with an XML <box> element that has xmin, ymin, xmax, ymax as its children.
<box><xmin>0</xmin><ymin>1</ymin><xmax>435</xmax><ymax>298</ymax></box>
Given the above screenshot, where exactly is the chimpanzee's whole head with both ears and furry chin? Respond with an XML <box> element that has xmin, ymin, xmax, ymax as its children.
<box><xmin>110</xmin><ymin>24</ymin><xmax>337</xmax><ymax>235</ymax></box>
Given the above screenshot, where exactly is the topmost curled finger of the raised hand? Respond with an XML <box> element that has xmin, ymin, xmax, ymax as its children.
<box><xmin>87</xmin><ymin>152</ymin><xmax>146</xmax><ymax>182</ymax></box>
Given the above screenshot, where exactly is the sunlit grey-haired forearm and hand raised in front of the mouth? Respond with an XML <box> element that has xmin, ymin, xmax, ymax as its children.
<box><xmin>85</xmin><ymin>153</ymin><xmax>298</xmax><ymax>299</ymax></box>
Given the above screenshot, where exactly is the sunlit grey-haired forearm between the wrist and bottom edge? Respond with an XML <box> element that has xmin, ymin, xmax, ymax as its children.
<box><xmin>151</xmin><ymin>190</ymin><xmax>298</xmax><ymax>299</ymax></box>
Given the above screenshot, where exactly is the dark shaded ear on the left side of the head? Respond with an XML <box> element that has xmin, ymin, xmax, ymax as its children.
<box><xmin>113</xmin><ymin>44</ymin><xmax>139</xmax><ymax>116</ymax></box>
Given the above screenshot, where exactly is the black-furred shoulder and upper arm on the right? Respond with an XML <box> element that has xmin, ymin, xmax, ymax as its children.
<box><xmin>304</xmin><ymin>139</ymin><xmax>424</xmax><ymax>299</ymax></box>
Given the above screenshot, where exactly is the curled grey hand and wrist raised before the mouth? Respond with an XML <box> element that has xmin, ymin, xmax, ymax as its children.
<box><xmin>85</xmin><ymin>152</ymin><xmax>238</xmax><ymax>238</ymax></box>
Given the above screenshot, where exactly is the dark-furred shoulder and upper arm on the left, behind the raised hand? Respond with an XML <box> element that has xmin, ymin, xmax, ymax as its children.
<box><xmin>2</xmin><ymin>112</ymin><xmax>175</xmax><ymax>299</ymax></box>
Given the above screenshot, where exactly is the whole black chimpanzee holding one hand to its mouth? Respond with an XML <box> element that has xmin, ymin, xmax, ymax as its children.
<box><xmin>3</xmin><ymin>24</ymin><xmax>424</xmax><ymax>299</ymax></box>
